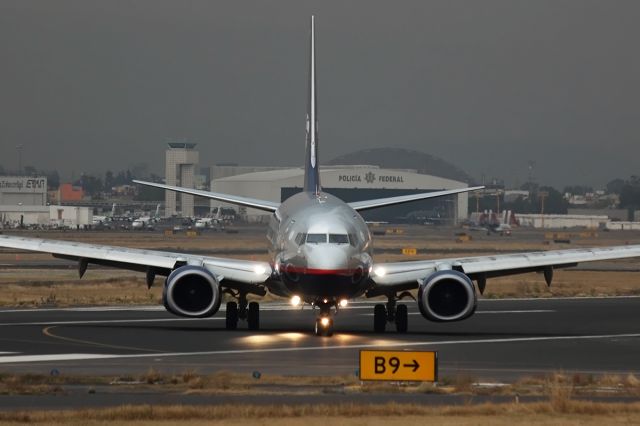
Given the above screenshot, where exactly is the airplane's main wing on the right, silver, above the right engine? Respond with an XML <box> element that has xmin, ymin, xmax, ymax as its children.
<box><xmin>371</xmin><ymin>245</ymin><xmax>640</xmax><ymax>290</ymax></box>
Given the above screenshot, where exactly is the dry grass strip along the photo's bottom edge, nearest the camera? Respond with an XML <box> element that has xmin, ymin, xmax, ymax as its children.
<box><xmin>0</xmin><ymin>401</ymin><xmax>640</xmax><ymax>425</ymax></box>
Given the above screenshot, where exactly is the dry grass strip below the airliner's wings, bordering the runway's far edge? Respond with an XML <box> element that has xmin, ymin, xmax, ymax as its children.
<box><xmin>0</xmin><ymin>269</ymin><xmax>640</xmax><ymax>307</ymax></box>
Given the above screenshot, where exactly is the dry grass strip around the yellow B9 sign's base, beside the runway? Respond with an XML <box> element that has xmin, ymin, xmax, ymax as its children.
<box><xmin>0</xmin><ymin>368</ymin><xmax>640</xmax><ymax>402</ymax></box>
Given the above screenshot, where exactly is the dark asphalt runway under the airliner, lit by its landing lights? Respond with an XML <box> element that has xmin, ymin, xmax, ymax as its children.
<box><xmin>0</xmin><ymin>297</ymin><xmax>640</xmax><ymax>380</ymax></box>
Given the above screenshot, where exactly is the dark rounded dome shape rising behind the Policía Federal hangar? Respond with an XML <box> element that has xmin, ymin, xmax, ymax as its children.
<box><xmin>326</xmin><ymin>148</ymin><xmax>474</xmax><ymax>184</ymax></box>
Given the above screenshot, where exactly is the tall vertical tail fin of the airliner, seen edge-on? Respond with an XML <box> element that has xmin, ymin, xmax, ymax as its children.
<box><xmin>304</xmin><ymin>15</ymin><xmax>320</xmax><ymax>194</ymax></box>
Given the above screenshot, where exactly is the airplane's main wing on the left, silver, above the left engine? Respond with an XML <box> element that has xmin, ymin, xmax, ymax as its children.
<box><xmin>0</xmin><ymin>235</ymin><xmax>272</xmax><ymax>285</ymax></box>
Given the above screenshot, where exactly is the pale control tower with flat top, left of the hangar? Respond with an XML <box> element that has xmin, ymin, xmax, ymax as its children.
<box><xmin>164</xmin><ymin>142</ymin><xmax>199</xmax><ymax>217</ymax></box>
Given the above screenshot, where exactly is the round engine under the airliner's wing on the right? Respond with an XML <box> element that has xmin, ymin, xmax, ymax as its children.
<box><xmin>418</xmin><ymin>270</ymin><xmax>477</xmax><ymax>322</ymax></box>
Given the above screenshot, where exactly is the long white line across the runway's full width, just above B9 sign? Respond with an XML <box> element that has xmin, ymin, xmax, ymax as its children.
<box><xmin>0</xmin><ymin>333</ymin><xmax>640</xmax><ymax>364</ymax></box>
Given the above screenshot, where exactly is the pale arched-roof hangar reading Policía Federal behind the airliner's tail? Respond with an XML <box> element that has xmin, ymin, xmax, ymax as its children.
<box><xmin>211</xmin><ymin>165</ymin><xmax>468</xmax><ymax>223</ymax></box>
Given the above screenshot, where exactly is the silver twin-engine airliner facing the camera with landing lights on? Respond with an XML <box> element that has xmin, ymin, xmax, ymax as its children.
<box><xmin>0</xmin><ymin>16</ymin><xmax>640</xmax><ymax>336</ymax></box>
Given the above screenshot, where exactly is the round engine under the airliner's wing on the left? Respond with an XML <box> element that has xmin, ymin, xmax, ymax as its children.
<box><xmin>162</xmin><ymin>265</ymin><xmax>222</xmax><ymax>318</ymax></box>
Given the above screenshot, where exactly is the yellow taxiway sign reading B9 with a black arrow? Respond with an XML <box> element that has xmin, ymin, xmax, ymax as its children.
<box><xmin>360</xmin><ymin>350</ymin><xmax>438</xmax><ymax>382</ymax></box>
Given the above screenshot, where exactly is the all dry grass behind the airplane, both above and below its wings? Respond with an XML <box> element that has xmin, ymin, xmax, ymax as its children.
<box><xmin>0</xmin><ymin>226</ymin><xmax>640</xmax><ymax>307</ymax></box>
